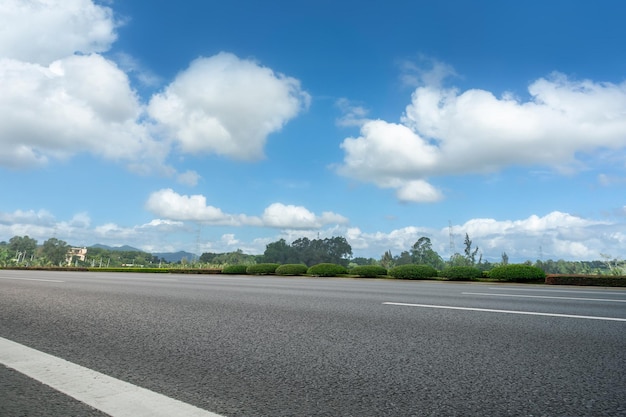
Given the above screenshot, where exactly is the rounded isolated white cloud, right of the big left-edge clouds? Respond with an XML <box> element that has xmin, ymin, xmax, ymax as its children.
<box><xmin>148</xmin><ymin>53</ymin><xmax>309</xmax><ymax>160</ymax></box>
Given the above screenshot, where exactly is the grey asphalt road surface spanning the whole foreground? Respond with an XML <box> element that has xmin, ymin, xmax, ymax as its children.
<box><xmin>0</xmin><ymin>270</ymin><xmax>626</xmax><ymax>417</ymax></box>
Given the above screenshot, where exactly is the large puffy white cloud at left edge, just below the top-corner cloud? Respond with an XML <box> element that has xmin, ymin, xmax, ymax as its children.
<box><xmin>0</xmin><ymin>55</ymin><xmax>165</xmax><ymax>168</ymax></box>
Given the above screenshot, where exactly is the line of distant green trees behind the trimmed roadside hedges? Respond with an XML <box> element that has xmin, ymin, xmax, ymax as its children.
<box><xmin>0</xmin><ymin>234</ymin><xmax>626</xmax><ymax>275</ymax></box>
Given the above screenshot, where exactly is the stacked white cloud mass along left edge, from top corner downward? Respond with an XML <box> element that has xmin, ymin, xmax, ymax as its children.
<box><xmin>0</xmin><ymin>0</ymin><xmax>168</xmax><ymax>171</ymax></box>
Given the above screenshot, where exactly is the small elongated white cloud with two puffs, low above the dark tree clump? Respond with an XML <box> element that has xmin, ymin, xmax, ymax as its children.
<box><xmin>146</xmin><ymin>188</ymin><xmax>348</xmax><ymax>229</ymax></box>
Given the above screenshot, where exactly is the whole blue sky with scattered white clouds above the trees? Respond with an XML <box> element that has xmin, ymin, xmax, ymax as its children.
<box><xmin>0</xmin><ymin>0</ymin><xmax>626</xmax><ymax>261</ymax></box>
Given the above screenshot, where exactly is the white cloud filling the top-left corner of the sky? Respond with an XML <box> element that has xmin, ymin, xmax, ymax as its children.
<box><xmin>0</xmin><ymin>0</ymin><xmax>117</xmax><ymax>66</ymax></box>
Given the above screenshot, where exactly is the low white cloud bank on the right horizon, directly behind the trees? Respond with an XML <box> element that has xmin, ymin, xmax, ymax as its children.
<box><xmin>339</xmin><ymin>211</ymin><xmax>626</xmax><ymax>262</ymax></box>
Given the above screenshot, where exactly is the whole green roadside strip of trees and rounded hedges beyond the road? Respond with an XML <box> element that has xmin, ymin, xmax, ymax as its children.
<box><xmin>0</xmin><ymin>234</ymin><xmax>626</xmax><ymax>286</ymax></box>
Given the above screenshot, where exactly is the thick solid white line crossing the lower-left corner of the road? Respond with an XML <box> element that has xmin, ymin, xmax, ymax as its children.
<box><xmin>0</xmin><ymin>337</ymin><xmax>220</xmax><ymax>417</ymax></box>
